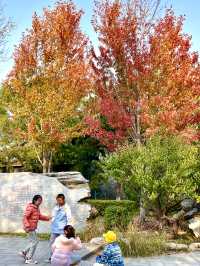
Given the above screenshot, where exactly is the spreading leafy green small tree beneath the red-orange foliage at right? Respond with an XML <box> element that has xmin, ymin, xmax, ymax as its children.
<box><xmin>102</xmin><ymin>136</ymin><xmax>200</xmax><ymax>218</ymax></box>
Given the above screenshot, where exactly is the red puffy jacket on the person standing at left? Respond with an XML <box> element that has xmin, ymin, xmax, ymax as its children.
<box><xmin>23</xmin><ymin>203</ymin><xmax>50</xmax><ymax>231</ymax></box>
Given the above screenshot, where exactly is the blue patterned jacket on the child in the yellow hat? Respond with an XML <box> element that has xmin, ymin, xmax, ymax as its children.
<box><xmin>96</xmin><ymin>242</ymin><xmax>124</xmax><ymax>266</ymax></box>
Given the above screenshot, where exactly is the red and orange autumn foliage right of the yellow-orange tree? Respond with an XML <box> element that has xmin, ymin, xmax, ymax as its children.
<box><xmin>87</xmin><ymin>0</ymin><xmax>200</xmax><ymax>150</ymax></box>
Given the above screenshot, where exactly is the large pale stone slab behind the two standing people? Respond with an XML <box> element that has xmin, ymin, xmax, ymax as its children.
<box><xmin>0</xmin><ymin>172</ymin><xmax>90</xmax><ymax>233</ymax></box>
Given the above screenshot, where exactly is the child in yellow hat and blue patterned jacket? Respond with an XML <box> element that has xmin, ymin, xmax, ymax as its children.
<box><xmin>96</xmin><ymin>231</ymin><xmax>124</xmax><ymax>266</ymax></box>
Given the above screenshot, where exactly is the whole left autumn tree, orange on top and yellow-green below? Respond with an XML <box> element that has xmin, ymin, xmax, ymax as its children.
<box><xmin>4</xmin><ymin>1</ymin><xmax>89</xmax><ymax>172</ymax></box>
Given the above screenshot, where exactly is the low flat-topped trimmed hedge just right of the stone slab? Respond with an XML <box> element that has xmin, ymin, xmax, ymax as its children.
<box><xmin>87</xmin><ymin>200</ymin><xmax>137</xmax><ymax>216</ymax></box>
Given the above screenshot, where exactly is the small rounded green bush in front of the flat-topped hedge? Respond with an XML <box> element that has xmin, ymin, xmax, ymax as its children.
<box><xmin>104</xmin><ymin>206</ymin><xmax>132</xmax><ymax>230</ymax></box>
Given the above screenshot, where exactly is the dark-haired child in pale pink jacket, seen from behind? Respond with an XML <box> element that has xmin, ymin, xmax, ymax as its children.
<box><xmin>51</xmin><ymin>225</ymin><xmax>82</xmax><ymax>266</ymax></box>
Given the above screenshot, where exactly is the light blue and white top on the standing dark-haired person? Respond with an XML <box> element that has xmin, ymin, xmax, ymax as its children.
<box><xmin>51</xmin><ymin>205</ymin><xmax>71</xmax><ymax>235</ymax></box>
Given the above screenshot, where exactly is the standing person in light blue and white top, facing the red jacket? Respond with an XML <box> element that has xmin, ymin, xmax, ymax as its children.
<box><xmin>47</xmin><ymin>194</ymin><xmax>71</xmax><ymax>262</ymax></box>
